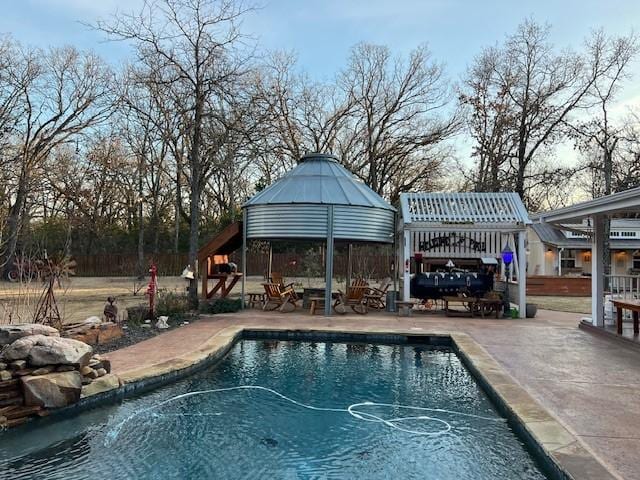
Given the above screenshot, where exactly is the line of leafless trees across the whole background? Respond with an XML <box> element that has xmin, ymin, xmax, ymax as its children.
<box><xmin>0</xmin><ymin>0</ymin><xmax>640</xmax><ymax>295</ymax></box>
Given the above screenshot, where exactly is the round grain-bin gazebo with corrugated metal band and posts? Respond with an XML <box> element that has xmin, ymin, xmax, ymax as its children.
<box><xmin>242</xmin><ymin>153</ymin><xmax>395</xmax><ymax>315</ymax></box>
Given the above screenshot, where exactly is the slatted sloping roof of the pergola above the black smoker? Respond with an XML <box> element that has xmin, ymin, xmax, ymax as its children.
<box><xmin>400</xmin><ymin>192</ymin><xmax>531</xmax><ymax>228</ymax></box>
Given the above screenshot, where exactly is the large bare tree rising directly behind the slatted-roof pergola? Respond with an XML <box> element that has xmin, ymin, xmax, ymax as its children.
<box><xmin>461</xmin><ymin>20</ymin><xmax>636</xmax><ymax>210</ymax></box>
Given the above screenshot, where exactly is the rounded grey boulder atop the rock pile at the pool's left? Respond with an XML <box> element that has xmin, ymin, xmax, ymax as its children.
<box><xmin>2</xmin><ymin>335</ymin><xmax>93</xmax><ymax>367</ymax></box>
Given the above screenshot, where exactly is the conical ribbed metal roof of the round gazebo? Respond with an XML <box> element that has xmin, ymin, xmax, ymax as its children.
<box><xmin>243</xmin><ymin>153</ymin><xmax>395</xmax><ymax>211</ymax></box>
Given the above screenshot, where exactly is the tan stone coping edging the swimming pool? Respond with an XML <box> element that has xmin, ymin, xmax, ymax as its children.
<box><xmin>15</xmin><ymin>325</ymin><xmax>620</xmax><ymax>480</ymax></box>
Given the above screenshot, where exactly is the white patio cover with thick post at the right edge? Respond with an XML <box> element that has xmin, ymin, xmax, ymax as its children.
<box><xmin>539</xmin><ymin>187</ymin><xmax>640</xmax><ymax>327</ymax></box>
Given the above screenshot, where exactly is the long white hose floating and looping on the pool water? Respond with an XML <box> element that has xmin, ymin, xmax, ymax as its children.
<box><xmin>105</xmin><ymin>385</ymin><xmax>504</xmax><ymax>444</ymax></box>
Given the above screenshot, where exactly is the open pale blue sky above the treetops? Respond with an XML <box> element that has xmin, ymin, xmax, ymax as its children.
<box><xmin>0</xmin><ymin>0</ymin><xmax>640</xmax><ymax>173</ymax></box>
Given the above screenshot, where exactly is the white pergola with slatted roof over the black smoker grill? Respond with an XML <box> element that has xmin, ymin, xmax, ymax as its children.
<box><xmin>398</xmin><ymin>192</ymin><xmax>531</xmax><ymax>318</ymax></box>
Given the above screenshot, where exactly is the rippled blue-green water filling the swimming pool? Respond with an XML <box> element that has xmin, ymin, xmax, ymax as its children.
<box><xmin>0</xmin><ymin>340</ymin><xmax>546</xmax><ymax>480</ymax></box>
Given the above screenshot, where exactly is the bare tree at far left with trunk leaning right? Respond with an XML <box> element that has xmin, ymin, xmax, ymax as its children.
<box><xmin>5</xmin><ymin>47</ymin><xmax>114</xmax><ymax>278</ymax></box>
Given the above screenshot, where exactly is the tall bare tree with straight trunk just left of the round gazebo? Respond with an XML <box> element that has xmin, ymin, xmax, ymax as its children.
<box><xmin>97</xmin><ymin>0</ymin><xmax>252</xmax><ymax>306</ymax></box>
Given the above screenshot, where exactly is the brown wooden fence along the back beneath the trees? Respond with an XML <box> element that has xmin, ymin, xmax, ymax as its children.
<box><xmin>74</xmin><ymin>253</ymin><xmax>393</xmax><ymax>278</ymax></box>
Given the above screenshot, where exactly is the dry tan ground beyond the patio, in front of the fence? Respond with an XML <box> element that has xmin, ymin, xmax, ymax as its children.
<box><xmin>0</xmin><ymin>277</ymin><xmax>591</xmax><ymax>324</ymax></box>
